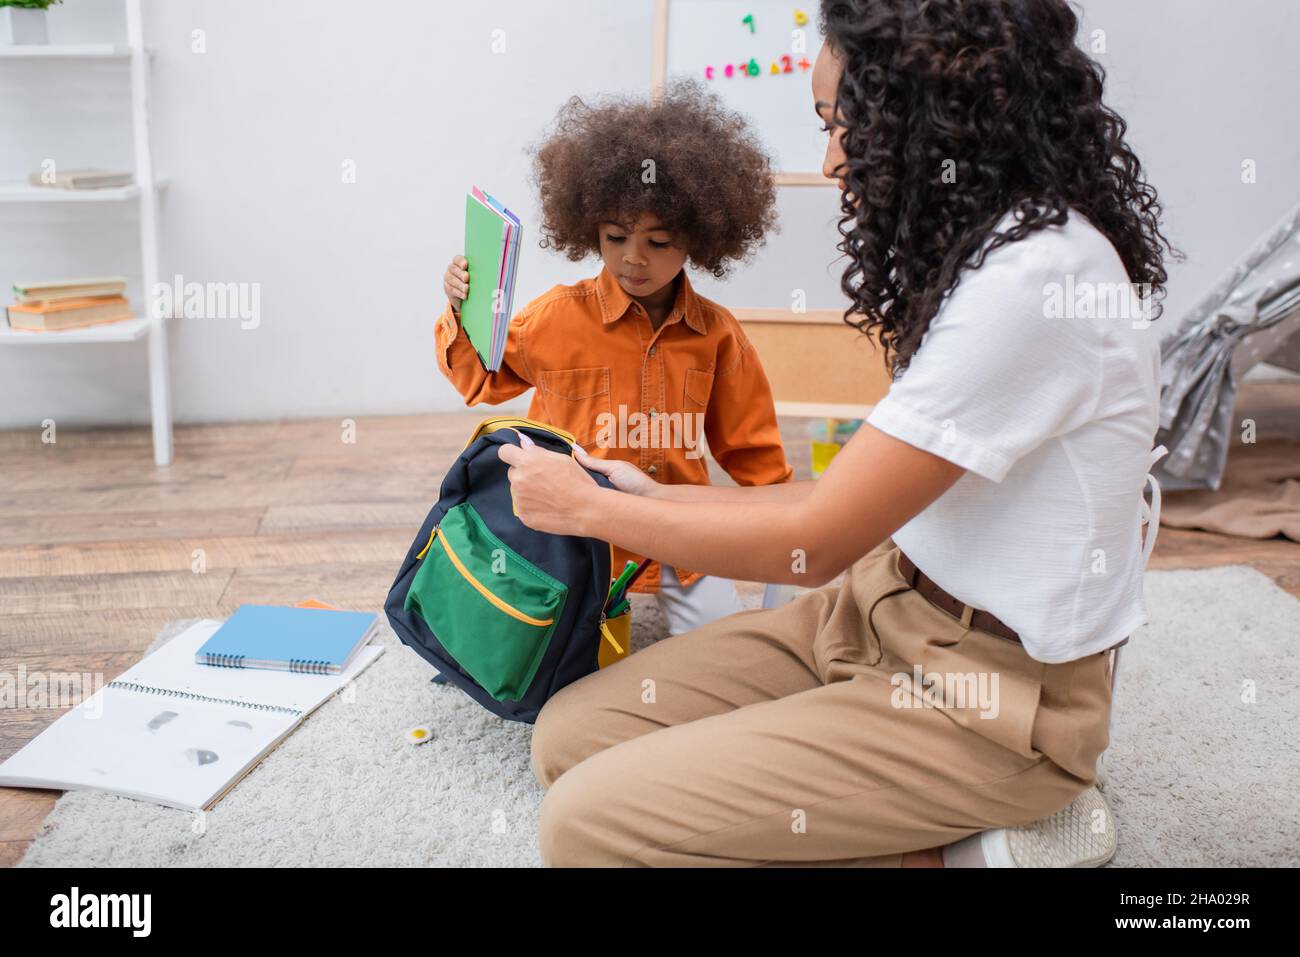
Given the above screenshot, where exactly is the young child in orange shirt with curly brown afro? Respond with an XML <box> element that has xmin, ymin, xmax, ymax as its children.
<box><xmin>437</xmin><ymin>83</ymin><xmax>793</xmax><ymax>635</ymax></box>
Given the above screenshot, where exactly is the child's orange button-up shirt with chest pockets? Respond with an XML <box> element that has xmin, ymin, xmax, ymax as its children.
<box><xmin>437</xmin><ymin>261</ymin><xmax>793</xmax><ymax>592</ymax></box>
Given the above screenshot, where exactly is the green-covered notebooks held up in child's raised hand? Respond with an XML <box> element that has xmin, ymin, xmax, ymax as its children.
<box><xmin>460</xmin><ymin>186</ymin><xmax>523</xmax><ymax>372</ymax></box>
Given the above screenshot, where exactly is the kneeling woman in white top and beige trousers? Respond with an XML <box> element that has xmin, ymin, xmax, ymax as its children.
<box><xmin>501</xmin><ymin>0</ymin><xmax>1171</xmax><ymax>866</ymax></box>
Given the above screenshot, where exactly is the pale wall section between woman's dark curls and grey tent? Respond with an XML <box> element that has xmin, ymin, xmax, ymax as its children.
<box><xmin>1083</xmin><ymin>0</ymin><xmax>1300</xmax><ymax>343</ymax></box>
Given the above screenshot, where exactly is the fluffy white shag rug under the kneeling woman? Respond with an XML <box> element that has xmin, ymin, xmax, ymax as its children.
<box><xmin>12</xmin><ymin>566</ymin><xmax>1300</xmax><ymax>867</ymax></box>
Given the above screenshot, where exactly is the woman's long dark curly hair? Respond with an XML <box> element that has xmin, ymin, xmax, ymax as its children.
<box><xmin>822</xmin><ymin>0</ymin><xmax>1178</xmax><ymax>376</ymax></box>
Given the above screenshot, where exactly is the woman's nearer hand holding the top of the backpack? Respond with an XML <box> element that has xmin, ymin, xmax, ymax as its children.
<box><xmin>497</xmin><ymin>436</ymin><xmax>601</xmax><ymax>536</ymax></box>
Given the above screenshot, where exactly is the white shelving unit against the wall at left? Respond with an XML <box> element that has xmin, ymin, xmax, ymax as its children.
<box><xmin>0</xmin><ymin>0</ymin><xmax>172</xmax><ymax>465</ymax></box>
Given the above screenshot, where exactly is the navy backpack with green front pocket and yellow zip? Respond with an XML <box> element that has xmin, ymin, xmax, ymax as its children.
<box><xmin>384</xmin><ymin>416</ymin><xmax>621</xmax><ymax>723</ymax></box>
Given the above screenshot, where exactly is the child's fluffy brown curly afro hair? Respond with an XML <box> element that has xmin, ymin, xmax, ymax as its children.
<box><xmin>533</xmin><ymin>81</ymin><xmax>776</xmax><ymax>278</ymax></box>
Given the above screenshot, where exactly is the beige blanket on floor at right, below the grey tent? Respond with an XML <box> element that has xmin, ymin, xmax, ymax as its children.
<box><xmin>1160</xmin><ymin>439</ymin><xmax>1300</xmax><ymax>541</ymax></box>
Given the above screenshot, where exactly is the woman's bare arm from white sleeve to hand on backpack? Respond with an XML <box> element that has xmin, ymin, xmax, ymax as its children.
<box><xmin>499</xmin><ymin>425</ymin><xmax>965</xmax><ymax>586</ymax></box>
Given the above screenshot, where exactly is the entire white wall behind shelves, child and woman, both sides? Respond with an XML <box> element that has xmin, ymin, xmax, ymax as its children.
<box><xmin>0</xmin><ymin>0</ymin><xmax>1300</xmax><ymax>428</ymax></box>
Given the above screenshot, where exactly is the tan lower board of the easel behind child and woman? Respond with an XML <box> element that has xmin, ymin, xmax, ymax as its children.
<box><xmin>732</xmin><ymin>308</ymin><xmax>892</xmax><ymax>419</ymax></box>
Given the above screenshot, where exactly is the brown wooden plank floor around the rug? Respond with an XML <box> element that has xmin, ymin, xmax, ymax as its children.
<box><xmin>0</xmin><ymin>382</ymin><xmax>1300</xmax><ymax>866</ymax></box>
